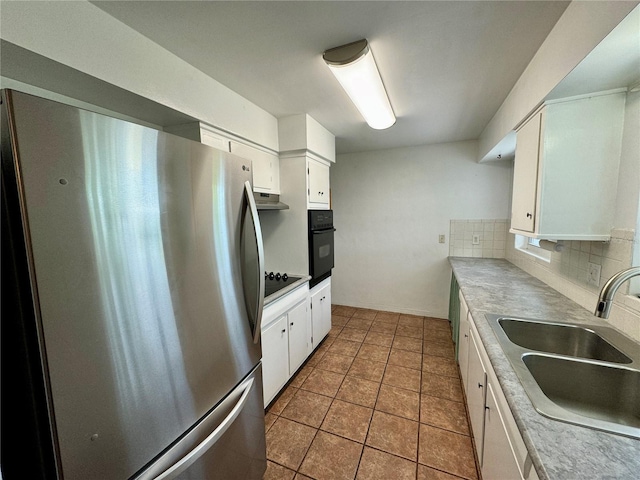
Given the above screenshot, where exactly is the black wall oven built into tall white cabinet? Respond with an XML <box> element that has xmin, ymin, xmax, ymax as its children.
<box><xmin>309</xmin><ymin>210</ymin><xmax>336</xmax><ymax>287</ymax></box>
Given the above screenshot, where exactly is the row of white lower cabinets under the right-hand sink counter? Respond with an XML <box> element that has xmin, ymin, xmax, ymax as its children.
<box><xmin>458</xmin><ymin>308</ymin><xmax>538</xmax><ymax>480</ymax></box>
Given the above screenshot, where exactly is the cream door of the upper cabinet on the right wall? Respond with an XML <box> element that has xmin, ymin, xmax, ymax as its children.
<box><xmin>511</xmin><ymin>113</ymin><xmax>542</xmax><ymax>232</ymax></box>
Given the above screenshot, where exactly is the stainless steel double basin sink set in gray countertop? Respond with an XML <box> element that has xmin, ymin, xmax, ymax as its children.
<box><xmin>485</xmin><ymin>314</ymin><xmax>640</xmax><ymax>439</ymax></box>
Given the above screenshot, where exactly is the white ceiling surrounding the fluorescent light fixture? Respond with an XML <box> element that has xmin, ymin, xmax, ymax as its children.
<box><xmin>92</xmin><ymin>1</ymin><xmax>569</xmax><ymax>153</ymax></box>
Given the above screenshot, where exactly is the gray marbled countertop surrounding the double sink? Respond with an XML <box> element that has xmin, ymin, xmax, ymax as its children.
<box><xmin>449</xmin><ymin>257</ymin><xmax>640</xmax><ymax>480</ymax></box>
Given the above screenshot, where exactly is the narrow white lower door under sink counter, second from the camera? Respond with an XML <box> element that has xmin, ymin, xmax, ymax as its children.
<box><xmin>467</xmin><ymin>331</ymin><xmax>487</xmax><ymax>465</ymax></box>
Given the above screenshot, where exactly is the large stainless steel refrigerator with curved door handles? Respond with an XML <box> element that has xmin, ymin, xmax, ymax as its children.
<box><xmin>2</xmin><ymin>90</ymin><xmax>266</xmax><ymax>480</ymax></box>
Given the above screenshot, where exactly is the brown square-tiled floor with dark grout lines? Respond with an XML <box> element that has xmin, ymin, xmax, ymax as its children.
<box><xmin>264</xmin><ymin>305</ymin><xmax>478</xmax><ymax>480</ymax></box>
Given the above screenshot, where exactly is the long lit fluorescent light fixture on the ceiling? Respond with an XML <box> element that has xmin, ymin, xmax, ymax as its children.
<box><xmin>322</xmin><ymin>40</ymin><xmax>396</xmax><ymax>130</ymax></box>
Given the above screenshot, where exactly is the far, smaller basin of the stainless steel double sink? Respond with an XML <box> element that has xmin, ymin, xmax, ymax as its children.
<box><xmin>498</xmin><ymin>318</ymin><xmax>631</xmax><ymax>363</ymax></box>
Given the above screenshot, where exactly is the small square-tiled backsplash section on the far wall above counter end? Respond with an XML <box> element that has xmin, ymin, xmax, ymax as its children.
<box><xmin>449</xmin><ymin>219</ymin><xmax>508</xmax><ymax>258</ymax></box>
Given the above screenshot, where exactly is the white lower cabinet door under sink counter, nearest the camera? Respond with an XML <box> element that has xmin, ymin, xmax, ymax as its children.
<box><xmin>482</xmin><ymin>383</ymin><xmax>522</xmax><ymax>480</ymax></box>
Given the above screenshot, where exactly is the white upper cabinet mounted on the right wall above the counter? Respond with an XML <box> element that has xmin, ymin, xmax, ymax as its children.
<box><xmin>510</xmin><ymin>91</ymin><xmax>625</xmax><ymax>241</ymax></box>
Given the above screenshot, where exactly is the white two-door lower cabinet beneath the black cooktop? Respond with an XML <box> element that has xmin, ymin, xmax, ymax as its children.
<box><xmin>261</xmin><ymin>284</ymin><xmax>311</xmax><ymax>407</ymax></box>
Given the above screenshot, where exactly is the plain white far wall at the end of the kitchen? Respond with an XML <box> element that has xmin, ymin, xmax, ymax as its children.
<box><xmin>331</xmin><ymin>141</ymin><xmax>513</xmax><ymax>318</ymax></box>
